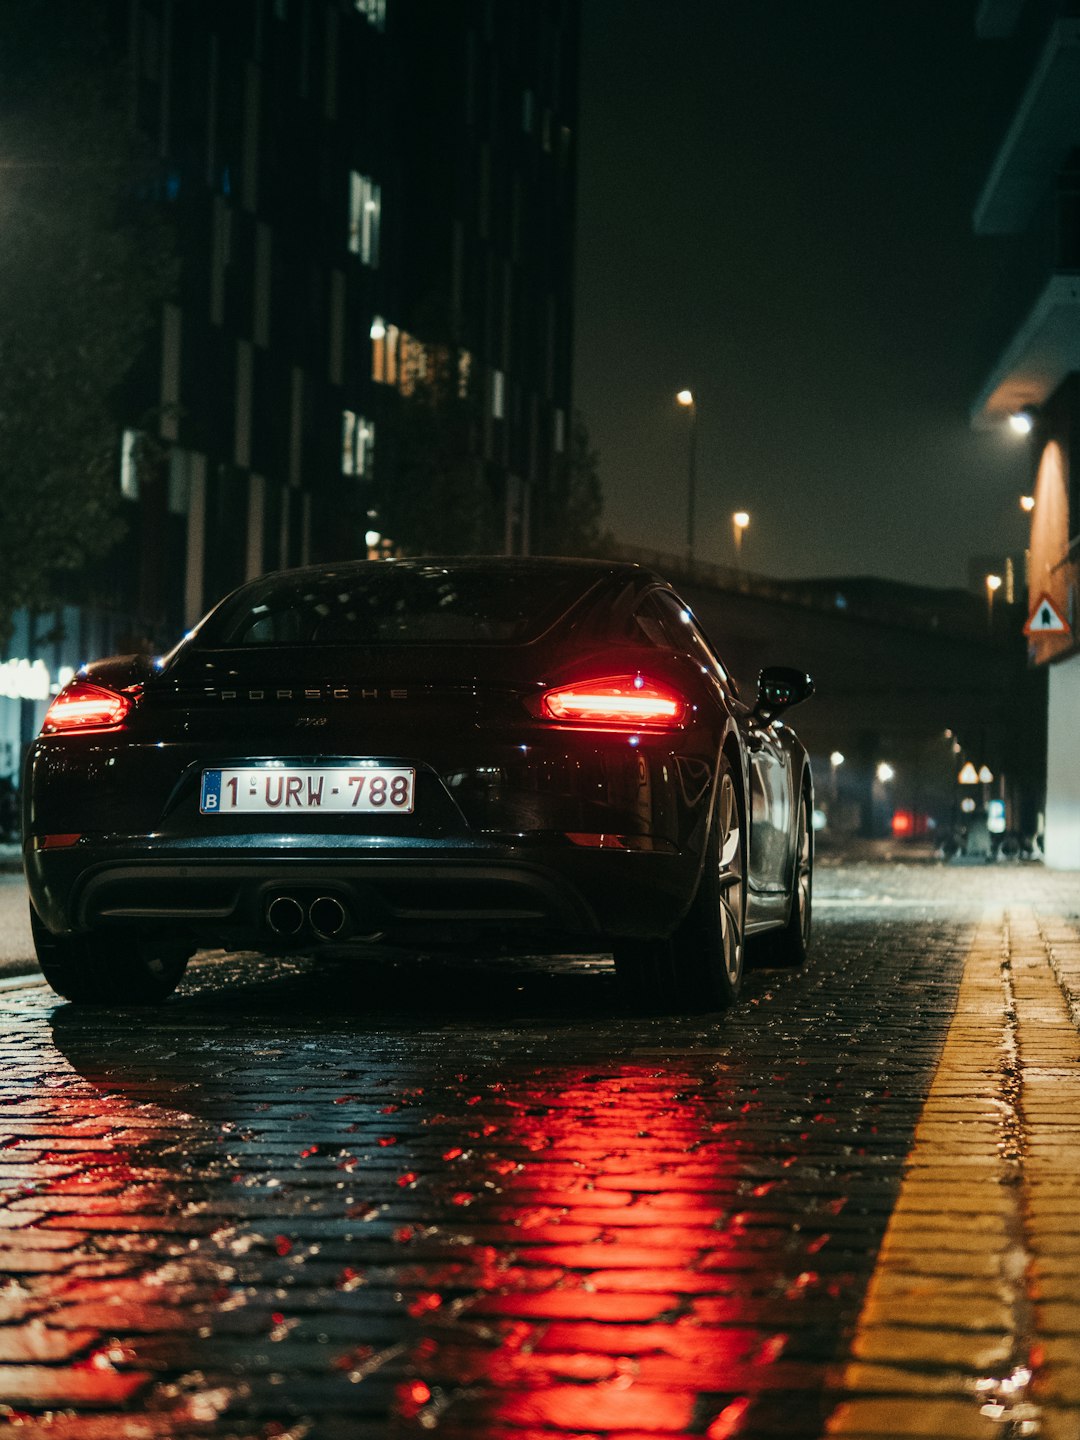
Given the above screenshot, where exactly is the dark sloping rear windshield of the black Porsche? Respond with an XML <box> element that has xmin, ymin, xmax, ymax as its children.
<box><xmin>196</xmin><ymin>562</ymin><xmax>596</xmax><ymax>648</ymax></box>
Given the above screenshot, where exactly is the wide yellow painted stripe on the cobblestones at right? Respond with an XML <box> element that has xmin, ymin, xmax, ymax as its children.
<box><xmin>825</xmin><ymin>910</ymin><xmax>1080</xmax><ymax>1440</ymax></box>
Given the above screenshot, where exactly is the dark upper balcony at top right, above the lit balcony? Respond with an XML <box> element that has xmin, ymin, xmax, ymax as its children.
<box><xmin>975</xmin><ymin>17</ymin><xmax>1080</xmax><ymax>235</ymax></box>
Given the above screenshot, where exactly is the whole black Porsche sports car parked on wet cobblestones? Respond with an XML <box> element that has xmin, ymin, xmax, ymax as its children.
<box><xmin>23</xmin><ymin>559</ymin><xmax>812</xmax><ymax>1008</ymax></box>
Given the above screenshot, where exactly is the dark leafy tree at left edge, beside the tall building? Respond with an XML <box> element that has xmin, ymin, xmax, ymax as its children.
<box><xmin>0</xmin><ymin>0</ymin><xmax>176</xmax><ymax>639</ymax></box>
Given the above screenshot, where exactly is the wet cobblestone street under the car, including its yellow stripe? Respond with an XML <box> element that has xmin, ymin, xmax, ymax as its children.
<box><xmin>0</xmin><ymin>864</ymin><xmax>1080</xmax><ymax>1440</ymax></box>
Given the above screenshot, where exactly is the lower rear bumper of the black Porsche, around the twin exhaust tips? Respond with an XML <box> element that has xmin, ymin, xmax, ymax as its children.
<box><xmin>26</xmin><ymin>837</ymin><xmax>698</xmax><ymax>946</ymax></box>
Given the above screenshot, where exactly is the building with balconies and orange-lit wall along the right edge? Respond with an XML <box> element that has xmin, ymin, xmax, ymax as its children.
<box><xmin>973</xmin><ymin>0</ymin><xmax>1080</xmax><ymax>870</ymax></box>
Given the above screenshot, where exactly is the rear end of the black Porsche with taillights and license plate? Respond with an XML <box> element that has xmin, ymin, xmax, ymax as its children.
<box><xmin>23</xmin><ymin>561</ymin><xmax>716</xmax><ymax>949</ymax></box>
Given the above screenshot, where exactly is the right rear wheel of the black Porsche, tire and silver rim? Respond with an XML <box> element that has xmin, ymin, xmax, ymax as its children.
<box><xmin>615</xmin><ymin>756</ymin><xmax>746</xmax><ymax>1012</ymax></box>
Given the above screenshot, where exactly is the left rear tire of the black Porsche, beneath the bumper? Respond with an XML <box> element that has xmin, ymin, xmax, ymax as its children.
<box><xmin>30</xmin><ymin>906</ymin><xmax>192</xmax><ymax>1005</ymax></box>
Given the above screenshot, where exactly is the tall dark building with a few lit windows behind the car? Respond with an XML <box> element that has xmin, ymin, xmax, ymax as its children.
<box><xmin>0</xmin><ymin>0</ymin><xmax>579</xmax><ymax>789</ymax></box>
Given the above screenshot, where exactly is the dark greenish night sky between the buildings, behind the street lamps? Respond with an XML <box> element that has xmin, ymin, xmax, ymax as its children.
<box><xmin>575</xmin><ymin>0</ymin><xmax>1028</xmax><ymax>585</ymax></box>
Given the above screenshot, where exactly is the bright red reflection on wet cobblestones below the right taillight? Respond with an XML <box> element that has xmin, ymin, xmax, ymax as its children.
<box><xmin>385</xmin><ymin>1064</ymin><xmax>804</xmax><ymax>1440</ymax></box>
